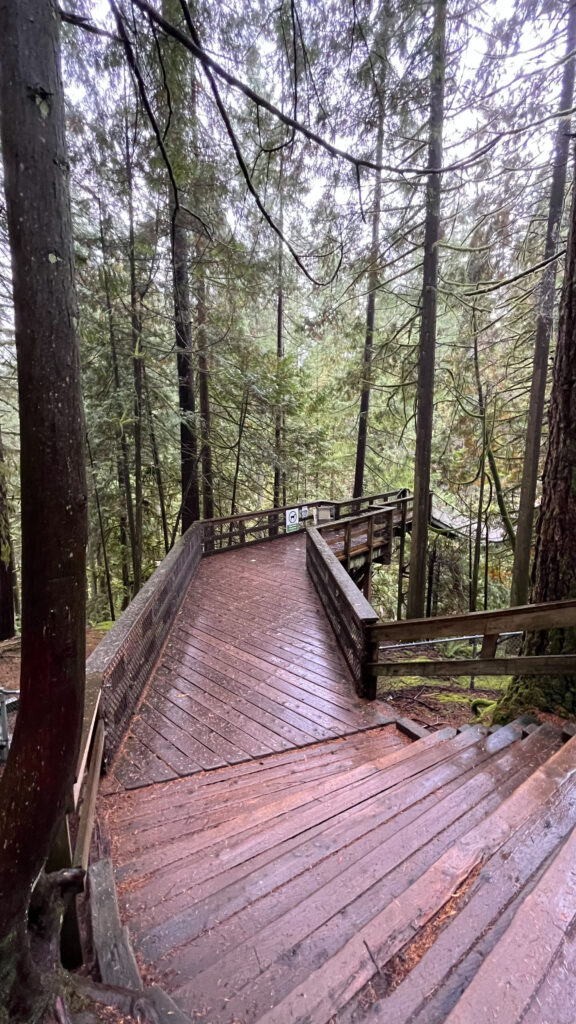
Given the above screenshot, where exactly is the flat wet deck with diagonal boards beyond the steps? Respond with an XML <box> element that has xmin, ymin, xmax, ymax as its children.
<box><xmin>102</xmin><ymin>535</ymin><xmax>393</xmax><ymax>793</ymax></box>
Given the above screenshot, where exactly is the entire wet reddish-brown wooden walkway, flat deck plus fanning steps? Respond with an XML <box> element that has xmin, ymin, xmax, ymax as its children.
<box><xmin>90</xmin><ymin>516</ymin><xmax>576</xmax><ymax>1024</ymax></box>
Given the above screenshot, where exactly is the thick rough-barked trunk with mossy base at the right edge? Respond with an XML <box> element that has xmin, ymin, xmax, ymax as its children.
<box><xmin>496</xmin><ymin>148</ymin><xmax>576</xmax><ymax>721</ymax></box>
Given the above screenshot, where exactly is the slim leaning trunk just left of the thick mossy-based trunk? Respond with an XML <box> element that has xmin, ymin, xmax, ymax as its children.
<box><xmin>510</xmin><ymin>3</ymin><xmax>576</xmax><ymax>605</ymax></box>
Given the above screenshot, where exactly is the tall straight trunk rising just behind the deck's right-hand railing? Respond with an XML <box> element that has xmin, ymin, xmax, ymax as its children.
<box><xmin>406</xmin><ymin>0</ymin><xmax>447</xmax><ymax>618</ymax></box>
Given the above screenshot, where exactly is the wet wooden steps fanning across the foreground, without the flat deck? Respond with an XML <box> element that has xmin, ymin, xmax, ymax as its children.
<box><xmin>102</xmin><ymin>723</ymin><xmax>576</xmax><ymax>1024</ymax></box>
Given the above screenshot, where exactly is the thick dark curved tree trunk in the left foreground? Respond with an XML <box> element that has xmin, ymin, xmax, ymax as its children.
<box><xmin>0</xmin><ymin>0</ymin><xmax>87</xmax><ymax>1022</ymax></box>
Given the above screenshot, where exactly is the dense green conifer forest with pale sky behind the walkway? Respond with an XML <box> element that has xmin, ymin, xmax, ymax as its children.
<box><xmin>0</xmin><ymin>0</ymin><xmax>575</xmax><ymax>622</ymax></box>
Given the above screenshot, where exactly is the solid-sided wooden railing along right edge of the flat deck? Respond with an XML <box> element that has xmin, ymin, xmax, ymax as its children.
<box><xmin>306</xmin><ymin>527</ymin><xmax>378</xmax><ymax>696</ymax></box>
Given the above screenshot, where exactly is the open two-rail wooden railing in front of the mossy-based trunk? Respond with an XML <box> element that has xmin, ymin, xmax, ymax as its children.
<box><xmin>365</xmin><ymin>600</ymin><xmax>576</xmax><ymax>693</ymax></box>
